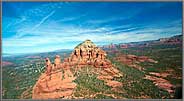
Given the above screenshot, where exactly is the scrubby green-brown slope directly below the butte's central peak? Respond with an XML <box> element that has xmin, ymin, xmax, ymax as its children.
<box><xmin>74</xmin><ymin>67</ymin><xmax>113</xmax><ymax>99</ymax></box>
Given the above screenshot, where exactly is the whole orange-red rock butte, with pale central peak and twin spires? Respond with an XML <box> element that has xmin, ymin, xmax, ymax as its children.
<box><xmin>32</xmin><ymin>40</ymin><xmax>122</xmax><ymax>99</ymax></box>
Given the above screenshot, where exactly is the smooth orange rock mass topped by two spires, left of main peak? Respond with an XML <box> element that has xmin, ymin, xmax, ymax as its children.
<box><xmin>32</xmin><ymin>55</ymin><xmax>76</xmax><ymax>99</ymax></box>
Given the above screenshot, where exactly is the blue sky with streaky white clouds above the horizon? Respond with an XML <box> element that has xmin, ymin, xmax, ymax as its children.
<box><xmin>2</xmin><ymin>2</ymin><xmax>182</xmax><ymax>54</ymax></box>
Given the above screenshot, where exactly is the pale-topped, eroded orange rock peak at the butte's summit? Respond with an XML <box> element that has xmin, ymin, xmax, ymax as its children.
<box><xmin>70</xmin><ymin>40</ymin><xmax>112</xmax><ymax>68</ymax></box>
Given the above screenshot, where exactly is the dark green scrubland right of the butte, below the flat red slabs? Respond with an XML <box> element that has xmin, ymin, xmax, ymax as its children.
<box><xmin>110</xmin><ymin>61</ymin><xmax>170</xmax><ymax>99</ymax></box>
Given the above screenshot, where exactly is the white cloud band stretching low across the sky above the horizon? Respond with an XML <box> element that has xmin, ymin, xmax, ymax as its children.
<box><xmin>3</xmin><ymin>17</ymin><xmax>182</xmax><ymax>48</ymax></box>
